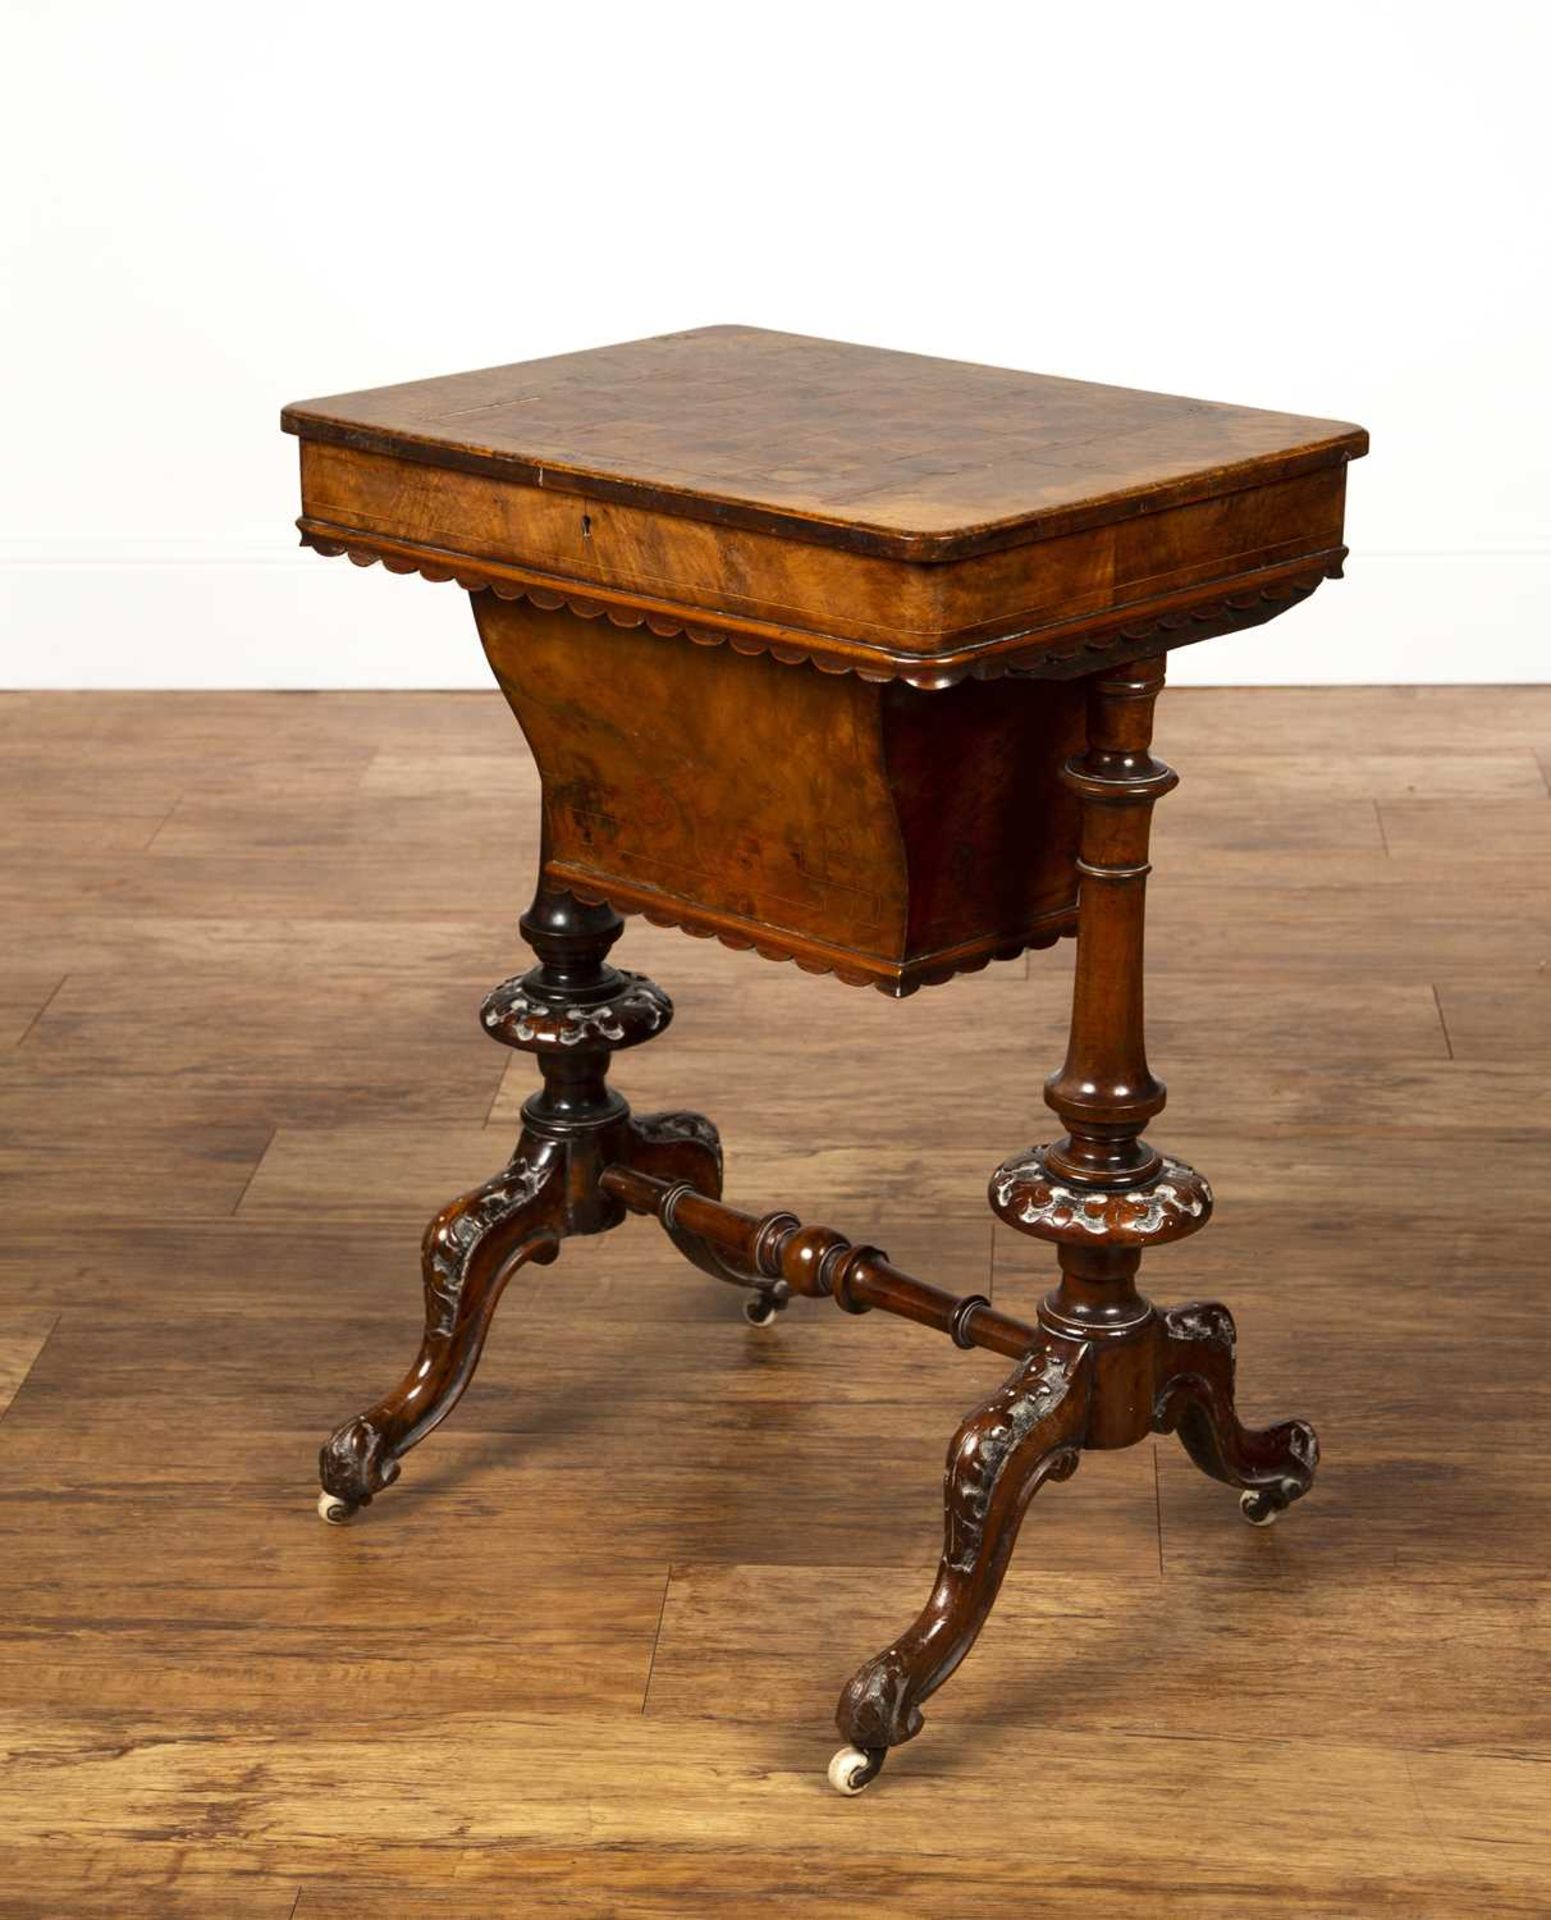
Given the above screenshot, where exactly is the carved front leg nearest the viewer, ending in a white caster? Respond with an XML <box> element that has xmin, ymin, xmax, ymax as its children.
<box><xmin>829</xmin><ymin>1336</ymin><xmax>1092</xmax><ymax>1793</ymax></box>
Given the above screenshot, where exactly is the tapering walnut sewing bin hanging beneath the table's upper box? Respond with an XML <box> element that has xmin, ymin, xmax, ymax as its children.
<box><xmin>472</xmin><ymin>593</ymin><xmax>1081</xmax><ymax>993</ymax></box>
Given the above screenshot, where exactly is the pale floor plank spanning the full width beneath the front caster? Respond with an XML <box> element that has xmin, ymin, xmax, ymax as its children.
<box><xmin>0</xmin><ymin>1713</ymin><xmax>1551</xmax><ymax>1912</ymax></box>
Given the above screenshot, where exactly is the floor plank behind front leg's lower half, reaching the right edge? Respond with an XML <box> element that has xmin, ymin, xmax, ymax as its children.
<box><xmin>647</xmin><ymin>1559</ymin><xmax>1551</xmax><ymax>1763</ymax></box>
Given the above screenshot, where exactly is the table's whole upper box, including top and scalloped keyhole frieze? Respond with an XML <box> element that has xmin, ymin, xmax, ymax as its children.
<box><xmin>282</xmin><ymin>328</ymin><xmax>1367</xmax><ymax>689</ymax></box>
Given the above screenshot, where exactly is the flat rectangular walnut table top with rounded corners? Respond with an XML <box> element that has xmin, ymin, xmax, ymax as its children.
<box><xmin>282</xmin><ymin>326</ymin><xmax>1367</xmax><ymax>563</ymax></box>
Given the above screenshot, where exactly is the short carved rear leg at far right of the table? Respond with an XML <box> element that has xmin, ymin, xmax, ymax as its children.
<box><xmin>1154</xmin><ymin>1302</ymin><xmax>1319</xmax><ymax>1526</ymax></box>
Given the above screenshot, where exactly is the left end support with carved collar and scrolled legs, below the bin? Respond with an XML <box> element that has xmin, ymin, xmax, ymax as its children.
<box><xmin>319</xmin><ymin>887</ymin><xmax>722</xmax><ymax>1521</ymax></box>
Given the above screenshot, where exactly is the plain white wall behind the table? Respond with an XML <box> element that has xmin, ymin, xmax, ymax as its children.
<box><xmin>0</xmin><ymin>0</ymin><xmax>1551</xmax><ymax>687</ymax></box>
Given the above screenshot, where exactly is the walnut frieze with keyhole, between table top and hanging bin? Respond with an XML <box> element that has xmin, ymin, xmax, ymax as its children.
<box><xmin>301</xmin><ymin>442</ymin><xmax>1346</xmax><ymax>655</ymax></box>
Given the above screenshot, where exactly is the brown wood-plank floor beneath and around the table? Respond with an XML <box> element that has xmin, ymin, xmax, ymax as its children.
<box><xmin>0</xmin><ymin>689</ymin><xmax>1551</xmax><ymax>1920</ymax></box>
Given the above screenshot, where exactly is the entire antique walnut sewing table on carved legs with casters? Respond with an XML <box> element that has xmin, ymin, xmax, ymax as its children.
<box><xmin>284</xmin><ymin>326</ymin><xmax>1367</xmax><ymax>1791</ymax></box>
